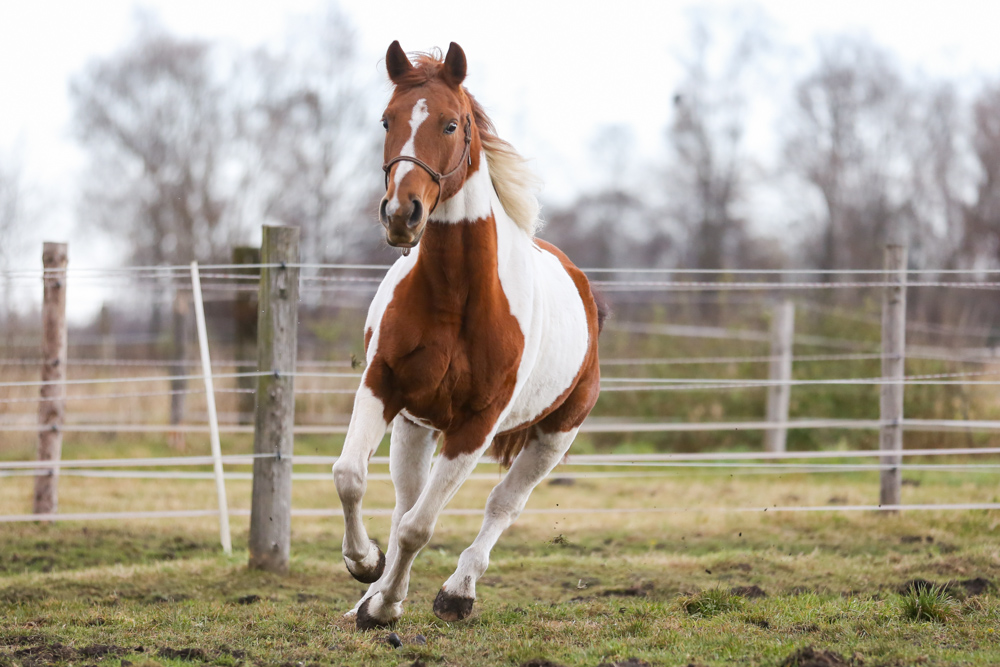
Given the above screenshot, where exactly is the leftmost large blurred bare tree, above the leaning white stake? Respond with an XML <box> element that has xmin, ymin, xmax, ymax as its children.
<box><xmin>70</xmin><ymin>18</ymin><xmax>242</xmax><ymax>264</ymax></box>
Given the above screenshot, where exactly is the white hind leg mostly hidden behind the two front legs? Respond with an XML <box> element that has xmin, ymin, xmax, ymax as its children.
<box><xmin>346</xmin><ymin>415</ymin><xmax>437</xmax><ymax>616</ymax></box>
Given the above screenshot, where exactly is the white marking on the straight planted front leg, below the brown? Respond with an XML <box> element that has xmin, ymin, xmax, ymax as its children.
<box><xmin>368</xmin><ymin>433</ymin><xmax>494</xmax><ymax>622</ymax></box>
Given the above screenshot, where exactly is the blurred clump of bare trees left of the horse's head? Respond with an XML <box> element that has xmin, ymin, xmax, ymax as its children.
<box><xmin>70</xmin><ymin>7</ymin><xmax>390</xmax><ymax>264</ymax></box>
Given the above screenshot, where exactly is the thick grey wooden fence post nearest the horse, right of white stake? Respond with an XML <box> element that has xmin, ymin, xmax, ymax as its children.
<box><xmin>249</xmin><ymin>226</ymin><xmax>299</xmax><ymax>572</ymax></box>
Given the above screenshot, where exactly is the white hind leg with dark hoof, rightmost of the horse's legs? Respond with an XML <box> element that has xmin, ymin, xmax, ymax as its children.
<box><xmin>434</xmin><ymin>428</ymin><xmax>578</xmax><ymax>621</ymax></box>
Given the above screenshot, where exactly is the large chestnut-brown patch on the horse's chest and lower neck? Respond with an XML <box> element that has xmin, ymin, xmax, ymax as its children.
<box><xmin>366</xmin><ymin>216</ymin><xmax>524</xmax><ymax>458</ymax></box>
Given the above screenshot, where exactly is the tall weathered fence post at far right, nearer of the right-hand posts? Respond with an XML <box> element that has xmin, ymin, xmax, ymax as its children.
<box><xmin>879</xmin><ymin>244</ymin><xmax>906</xmax><ymax>505</ymax></box>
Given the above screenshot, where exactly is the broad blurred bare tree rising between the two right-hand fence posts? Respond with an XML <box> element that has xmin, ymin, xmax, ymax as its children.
<box><xmin>784</xmin><ymin>36</ymin><xmax>914</xmax><ymax>269</ymax></box>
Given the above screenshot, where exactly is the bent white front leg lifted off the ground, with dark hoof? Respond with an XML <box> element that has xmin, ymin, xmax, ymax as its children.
<box><xmin>333</xmin><ymin>377</ymin><xmax>388</xmax><ymax>584</ymax></box>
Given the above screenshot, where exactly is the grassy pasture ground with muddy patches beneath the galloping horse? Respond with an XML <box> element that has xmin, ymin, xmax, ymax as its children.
<box><xmin>0</xmin><ymin>450</ymin><xmax>1000</xmax><ymax>667</ymax></box>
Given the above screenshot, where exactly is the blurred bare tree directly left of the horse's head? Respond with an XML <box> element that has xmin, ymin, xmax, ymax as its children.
<box><xmin>238</xmin><ymin>6</ymin><xmax>382</xmax><ymax>261</ymax></box>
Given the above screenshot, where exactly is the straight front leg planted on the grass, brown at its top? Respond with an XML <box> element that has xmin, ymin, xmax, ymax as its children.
<box><xmin>357</xmin><ymin>424</ymin><xmax>495</xmax><ymax>630</ymax></box>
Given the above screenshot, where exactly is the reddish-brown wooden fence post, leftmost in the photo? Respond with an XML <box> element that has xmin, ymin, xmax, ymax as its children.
<box><xmin>34</xmin><ymin>242</ymin><xmax>68</xmax><ymax>514</ymax></box>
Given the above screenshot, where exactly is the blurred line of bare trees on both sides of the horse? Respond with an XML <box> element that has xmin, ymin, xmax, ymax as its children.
<box><xmin>27</xmin><ymin>7</ymin><xmax>1000</xmax><ymax>334</ymax></box>
